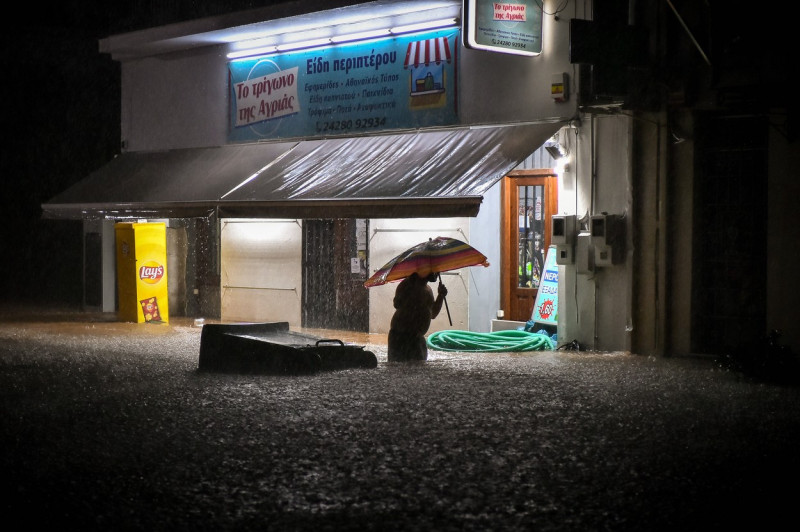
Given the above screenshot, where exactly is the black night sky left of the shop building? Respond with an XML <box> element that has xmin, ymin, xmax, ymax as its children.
<box><xmin>0</xmin><ymin>0</ymin><xmax>268</xmax><ymax>305</ymax></box>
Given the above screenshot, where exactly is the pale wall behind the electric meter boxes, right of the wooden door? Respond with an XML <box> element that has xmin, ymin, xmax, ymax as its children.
<box><xmin>558</xmin><ymin>115</ymin><xmax>634</xmax><ymax>351</ymax></box>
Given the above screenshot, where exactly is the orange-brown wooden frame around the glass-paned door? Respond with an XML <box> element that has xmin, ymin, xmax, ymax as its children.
<box><xmin>500</xmin><ymin>168</ymin><xmax>558</xmax><ymax>319</ymax></box>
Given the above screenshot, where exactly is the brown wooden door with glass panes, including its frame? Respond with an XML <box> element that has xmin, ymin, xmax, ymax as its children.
<box><xmin>500</xmin><ymin>169</ymin><xmax>558</xmax><ymax>321</ymax></box>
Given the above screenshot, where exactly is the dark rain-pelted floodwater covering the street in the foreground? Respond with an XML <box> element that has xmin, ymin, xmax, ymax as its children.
<box><xmin>0</xmin><ymin>309</ymin><xmax>800</xmax><ymax>531</ymax></box>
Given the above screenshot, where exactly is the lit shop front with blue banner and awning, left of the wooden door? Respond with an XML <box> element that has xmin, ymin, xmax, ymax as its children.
<box><xmin>45</xmin><ymin>2</ymin><xmax>576</xmax><ymax>332</ymax></box>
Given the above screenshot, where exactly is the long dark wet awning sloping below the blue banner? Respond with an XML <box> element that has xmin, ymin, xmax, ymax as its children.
<box><xmin>42</xmin><ymin>123</ymin><xmax>561</xmax><ymax>219</ymax></box>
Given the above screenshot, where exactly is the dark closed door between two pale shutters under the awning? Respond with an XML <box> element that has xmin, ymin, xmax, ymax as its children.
<box><xmin>301</xmin><ymin>218</ymin><xmax>369</xmax><ymax>332</ymax></box>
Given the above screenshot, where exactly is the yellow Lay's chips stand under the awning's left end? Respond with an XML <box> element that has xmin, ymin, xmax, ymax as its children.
<box><xmin>114</xmin><ymin>222</ymin><xmax>169</xmax><ymax>323</ymax></box>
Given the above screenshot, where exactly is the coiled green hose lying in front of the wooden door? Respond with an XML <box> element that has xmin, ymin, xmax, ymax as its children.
<box><xmin>427</xmin><ymin>330</ymin><xmax>555</xmax><ymax>352</ymax></box>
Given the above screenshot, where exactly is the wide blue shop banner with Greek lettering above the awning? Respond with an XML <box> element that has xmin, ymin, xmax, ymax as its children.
<box><xmin>228</xmin><ymin>28</ymin><xmax>460</xmax><ymax>142</ymax></box>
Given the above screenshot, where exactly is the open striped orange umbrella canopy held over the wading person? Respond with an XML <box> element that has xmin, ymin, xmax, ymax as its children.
<box><xmin>364</xmin><ymin>236</ymin><xmax>489</xmax><ymax>288</ymax></box>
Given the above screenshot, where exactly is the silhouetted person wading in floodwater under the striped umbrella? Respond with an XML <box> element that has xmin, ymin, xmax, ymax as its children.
<box><xmin>388</xmin><ymin>273</ymin><xmax>447</xmax><ymax>361</ymax></box>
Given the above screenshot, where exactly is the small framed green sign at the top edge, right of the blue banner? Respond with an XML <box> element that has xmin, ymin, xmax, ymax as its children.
<box><xmin>464</xmin><ymin>0</ymin><xmax>542</xmax><ymax>55</ymax></box>
